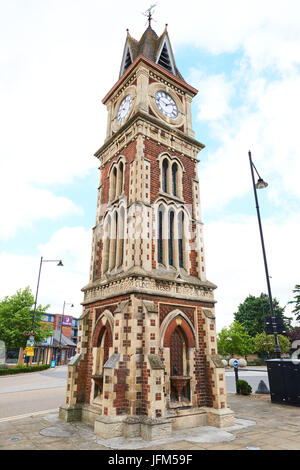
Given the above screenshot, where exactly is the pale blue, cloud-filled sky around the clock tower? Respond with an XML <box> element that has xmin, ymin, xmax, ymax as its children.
<box><xmin>0</xmin><ymin>0</ymin><xmax>300</xmax><ymax>331</ymax></box>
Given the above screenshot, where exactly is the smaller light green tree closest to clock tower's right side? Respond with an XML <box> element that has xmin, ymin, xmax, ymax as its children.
<box><xmin>218</xmin><ymin>321</ymin><xmax>253</xmax><ymax>358</ymax></box>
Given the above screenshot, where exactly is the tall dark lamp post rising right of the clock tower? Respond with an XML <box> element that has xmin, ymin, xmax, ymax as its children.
<box><xmin>248</xmin><ymin>151</ymin><xmax>281</xmax><ymax>359</ymax></box>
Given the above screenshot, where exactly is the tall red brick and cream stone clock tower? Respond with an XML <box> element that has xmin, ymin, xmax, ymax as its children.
<box><xmin>60</xmin><ymin>21</ymin><xmax>233</xmax><ymax>440</ymax></box>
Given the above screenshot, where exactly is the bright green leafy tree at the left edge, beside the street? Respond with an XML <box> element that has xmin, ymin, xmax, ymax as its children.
<box><xmin>0</xmin><ymin>287</ymin><xmax>53</xmax><ymax>356</ymax></box>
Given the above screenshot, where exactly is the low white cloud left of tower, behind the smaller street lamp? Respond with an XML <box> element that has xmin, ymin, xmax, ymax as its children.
<box><xmin>0</xmin><ymin>227</ymin><xmax>92</xmax><ymax>317</ymax></box>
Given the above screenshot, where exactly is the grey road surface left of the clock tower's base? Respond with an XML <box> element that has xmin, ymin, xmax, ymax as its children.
<box><xmin>0</xmin><ymin>366</ymin><xmax>68</xmax><ymax>419</ymax></box>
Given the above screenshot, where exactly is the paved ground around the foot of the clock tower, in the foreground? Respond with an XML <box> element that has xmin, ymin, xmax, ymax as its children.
<box><xmin>0</xmin><ymin>394</ymin><xmax>300</xmax><ymax>451</ymax></box>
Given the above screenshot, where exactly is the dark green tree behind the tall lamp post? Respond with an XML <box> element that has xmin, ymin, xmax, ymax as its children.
<box><xmin>234</xmin><ymin>293</ymin><xmax>292</xmax><ymax>338</ymax></box>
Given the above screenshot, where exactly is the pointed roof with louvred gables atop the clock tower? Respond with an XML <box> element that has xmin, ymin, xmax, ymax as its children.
<box><xmin>119</xmin><ymin>24</ymin><xmax>184</xmax><ymax>80</ymax></box>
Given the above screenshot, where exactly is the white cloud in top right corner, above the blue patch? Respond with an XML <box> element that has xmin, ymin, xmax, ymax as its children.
<box><xmin>160</xmin><ymin>0</ymin><xmax>300</xmax><ymax>70</ymax></box>
